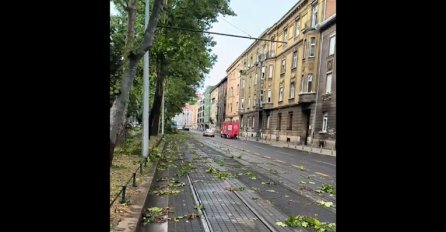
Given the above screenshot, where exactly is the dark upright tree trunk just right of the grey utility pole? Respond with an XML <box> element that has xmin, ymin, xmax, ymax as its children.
<box><xmin>149</xmin><ymin>60</ymin><xmax>165</xmax><ymax>136</ymax></box>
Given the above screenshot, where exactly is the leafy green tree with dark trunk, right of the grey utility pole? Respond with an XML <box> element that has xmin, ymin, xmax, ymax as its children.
<box><xmin>149</xmin><ymin>0</ymin><xmax>235</xmax><ymax>135</ymax></box>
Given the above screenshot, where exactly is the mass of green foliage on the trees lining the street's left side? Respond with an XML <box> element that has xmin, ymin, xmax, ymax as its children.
<box><xmin>110</xmin><ymin>0</ymin><xmax>235</xmax><ymax>131</ymax></box>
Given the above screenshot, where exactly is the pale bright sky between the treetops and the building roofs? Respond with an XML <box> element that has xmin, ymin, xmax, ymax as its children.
<box><xmin>110</xmin><ymin>0</ymin><xmax>299</xmax><ymax>93</ymax></box>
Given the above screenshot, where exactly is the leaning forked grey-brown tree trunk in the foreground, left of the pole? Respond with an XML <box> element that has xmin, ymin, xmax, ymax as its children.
<box><xmin>110</xmin><ymin>0</ymin><xmax>164</xmax><ymax>165</ymax></box>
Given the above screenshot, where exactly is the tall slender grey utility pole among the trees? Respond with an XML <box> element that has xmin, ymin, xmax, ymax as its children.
<box><xmin>142</xmin><ymin>0</ymin><xmax>150</xmax><ymax>157</ymax></box>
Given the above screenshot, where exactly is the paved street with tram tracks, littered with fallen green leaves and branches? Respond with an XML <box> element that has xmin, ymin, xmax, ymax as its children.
<box><xmin>139</xmin><ymin>130</ymin><xmax>336</xmax><ymax>231</ymax></box>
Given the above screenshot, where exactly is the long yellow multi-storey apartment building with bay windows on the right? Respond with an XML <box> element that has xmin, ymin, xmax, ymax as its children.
<box><xmin>233</xmin><ymin>0</ymin><xmax>325</xmax><ymax>144</ymax></box>
